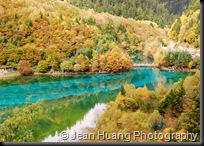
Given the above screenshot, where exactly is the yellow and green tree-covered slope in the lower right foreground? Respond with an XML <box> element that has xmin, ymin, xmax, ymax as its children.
<box><xmin>94</xmin><ymin>72</ymin><xmax>200</xmax><ymax>142</ymax></box>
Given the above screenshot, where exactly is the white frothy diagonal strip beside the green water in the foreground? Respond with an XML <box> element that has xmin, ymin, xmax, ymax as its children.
<box><xmin>42</xmin><ymin>103</ymin><xmax>106</xmax><ymax>142</ymax></box>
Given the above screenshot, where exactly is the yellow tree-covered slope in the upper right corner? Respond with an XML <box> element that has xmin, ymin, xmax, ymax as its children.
<box><xmin>169</xmin><ymin>0</ymin><xmax>200</xmax><ymax>48</ymax></box>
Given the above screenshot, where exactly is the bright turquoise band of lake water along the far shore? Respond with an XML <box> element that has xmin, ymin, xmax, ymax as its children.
<box><xmin>0</xmin><ymin>68</ymin><xmax>192</xmax><ymax>107</ymax></box>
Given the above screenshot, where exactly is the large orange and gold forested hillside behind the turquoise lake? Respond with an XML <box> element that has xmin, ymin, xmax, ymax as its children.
<box><xmin>0</xmin><ymin>0</ymin><xmax>166</xmax><ymax>75</ymax></box>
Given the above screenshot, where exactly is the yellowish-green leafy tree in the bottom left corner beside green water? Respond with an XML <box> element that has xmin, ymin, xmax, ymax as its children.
<box><xmin>0</xmin><ymin>103</ymin><xmax>42</xmax><ymax>142</ymax></box>
